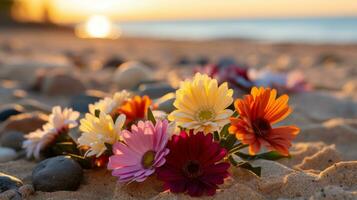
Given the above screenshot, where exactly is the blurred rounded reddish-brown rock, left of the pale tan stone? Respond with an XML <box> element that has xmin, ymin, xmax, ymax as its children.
<box><xmin>41</xmin><ymin>71</ymin><xmax>85</xmax><ymax>96</ymax></box>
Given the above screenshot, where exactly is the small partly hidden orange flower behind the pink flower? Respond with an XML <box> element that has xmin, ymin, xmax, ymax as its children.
<box><xmin>118</xmin><ymin>96</ymin><xmax>151</xmax><ymax>125</ymax></box>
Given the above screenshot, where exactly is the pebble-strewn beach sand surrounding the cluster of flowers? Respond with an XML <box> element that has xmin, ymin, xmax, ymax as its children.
<box><xmin>0</xmin><ymin>30</ymin><xmax>357</xmax><ymax>199</ymax></box>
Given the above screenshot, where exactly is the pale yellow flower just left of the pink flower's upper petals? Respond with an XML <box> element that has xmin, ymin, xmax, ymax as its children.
<box><xmin>78</xmin><ymin>113</ymin><xmax>125</xmax><ymax>157</ymax></box>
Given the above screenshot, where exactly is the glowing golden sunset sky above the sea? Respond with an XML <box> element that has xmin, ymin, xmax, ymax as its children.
<box><xmin>14</xmin><ymin>0</ymin><xmax>357</xmax><ymax>23</ymax></box>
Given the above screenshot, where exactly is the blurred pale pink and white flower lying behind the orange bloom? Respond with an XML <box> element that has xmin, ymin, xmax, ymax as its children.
<box><xmin>249</xmin><ymin>70</ymin><xmax>312</xmax><ymax>92</ymax></box>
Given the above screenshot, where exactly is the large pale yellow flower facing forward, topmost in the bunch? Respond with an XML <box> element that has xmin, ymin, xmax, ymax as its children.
<box><xmin>168</xmin><ymin>73</ymin><xmax>233</xmax><ymax>133</ymax></box>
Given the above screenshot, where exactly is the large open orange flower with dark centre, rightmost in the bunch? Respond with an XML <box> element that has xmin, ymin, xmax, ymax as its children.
<box><xmin>229</xmin><ymin>87</ymin><xmax>300</xmax><ymax>155</ymax></box>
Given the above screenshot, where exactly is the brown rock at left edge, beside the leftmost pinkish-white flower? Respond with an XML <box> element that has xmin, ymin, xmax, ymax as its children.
<box><xmin>0</xmin><ymin>112</ymin><xmax>48</xmax><ymax>135</ymax></box>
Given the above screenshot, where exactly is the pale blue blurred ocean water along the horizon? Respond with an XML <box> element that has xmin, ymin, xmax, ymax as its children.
<box><xmin>119</xmin><ymin>17</ymin><xmax>357</xmax><ymax>43</ymax></box>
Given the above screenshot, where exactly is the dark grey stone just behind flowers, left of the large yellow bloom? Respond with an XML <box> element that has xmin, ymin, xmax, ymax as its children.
<box><xmin>139</xmin><ymin>83</ymin><xmax>175</xmax><ymax>99</ymax></box>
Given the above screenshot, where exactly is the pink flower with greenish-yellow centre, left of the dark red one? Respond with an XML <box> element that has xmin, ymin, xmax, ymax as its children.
<box><xmin>108</xmin><ymin>120</ymin><xmax>170</xmax><ymax>182</ymax></box>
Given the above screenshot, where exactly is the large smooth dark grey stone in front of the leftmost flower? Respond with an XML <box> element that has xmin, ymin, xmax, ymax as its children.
<box><xmin>32</xmin><ymin>156</ymin><xmax>83</xmax><ymax>192</ymax></box>
